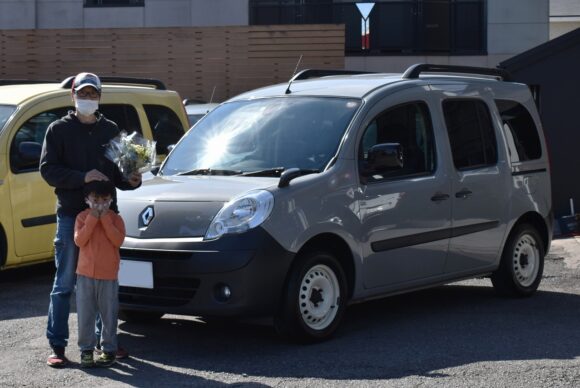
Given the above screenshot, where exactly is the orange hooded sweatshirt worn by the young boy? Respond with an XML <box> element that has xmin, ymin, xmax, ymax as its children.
<box><xmin>75</xmin><ymin>209</ymin><xmax>125</xmax><ymax>280</ymax></box>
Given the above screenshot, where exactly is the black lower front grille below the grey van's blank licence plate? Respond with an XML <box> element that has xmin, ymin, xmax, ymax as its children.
<box><xmin>119</xmin><ymin>278</ymin><xmax>199</xmax><ymax>307</ymax></box>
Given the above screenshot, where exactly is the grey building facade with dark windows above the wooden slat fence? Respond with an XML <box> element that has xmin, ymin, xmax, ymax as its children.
<box><xmin>0</xmin><ymin>0</ymin><xmax>548</xmax><ymax>71</ymax></box>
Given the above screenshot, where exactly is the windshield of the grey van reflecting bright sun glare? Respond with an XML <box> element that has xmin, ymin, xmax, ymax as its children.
<box><xmin>160</xmin><ymin>97</ymin><xmax>360</xmax><ymax>175</ymax></box>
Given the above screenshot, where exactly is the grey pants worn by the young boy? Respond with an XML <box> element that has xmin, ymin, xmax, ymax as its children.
<box><xmin>76</xmin><ymin>275</ymin><xmax>119</xmax><ymax>353</ymax></box>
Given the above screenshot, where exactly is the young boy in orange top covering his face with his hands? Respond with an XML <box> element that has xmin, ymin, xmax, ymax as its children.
<box><xmin>74</xmin><ymin>181</ymin><xmax>125</xmax><ymax>368</ymax></box>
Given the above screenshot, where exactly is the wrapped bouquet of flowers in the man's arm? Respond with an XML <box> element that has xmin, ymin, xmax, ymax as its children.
<box><xmin>105</xmin><ymin>131</ymin><xmax>155</xmax><ymax>179</ymax></box>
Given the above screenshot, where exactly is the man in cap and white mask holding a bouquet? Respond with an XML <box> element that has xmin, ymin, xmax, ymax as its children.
<box><xmin>40</xmin><ymin>73</ymin><xmax>141</xmax><ymax>367</ymax></box>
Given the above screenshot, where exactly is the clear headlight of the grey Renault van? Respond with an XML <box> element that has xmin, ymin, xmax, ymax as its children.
<box><xmin>204</xmin><ymin>190</ymin><xmax>274</xmax><ymax>240</ymax></box>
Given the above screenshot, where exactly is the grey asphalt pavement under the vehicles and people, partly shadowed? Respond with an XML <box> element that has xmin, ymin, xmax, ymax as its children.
<box><xmin>0</xmin><ymin>237</ymin><xmax>580</xmax><ymax>388</ymax></box>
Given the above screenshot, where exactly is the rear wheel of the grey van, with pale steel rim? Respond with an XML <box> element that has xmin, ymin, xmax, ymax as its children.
<box><xmin>491</xmin><ymin>224</ymin><xmax>545</xmax><ymax>296</ymax></box>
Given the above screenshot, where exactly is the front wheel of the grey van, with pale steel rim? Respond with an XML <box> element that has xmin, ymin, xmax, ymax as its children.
<box><xmin>274</xmin><ymin>252</ymin><xmax>347</xmax><ymax>342</ymax></box>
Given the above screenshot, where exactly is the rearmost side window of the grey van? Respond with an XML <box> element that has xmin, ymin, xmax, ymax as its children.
<box><xmin>495</xmin><ymin>100</ymin><xmax>542</xmax><ymax>162</ymax></box>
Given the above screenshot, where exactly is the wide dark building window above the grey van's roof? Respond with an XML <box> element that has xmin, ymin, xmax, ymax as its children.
<box><xmin>250</xmin><ymin>0</ymin><xmax>487</xmax><ymax>55</ymax></box>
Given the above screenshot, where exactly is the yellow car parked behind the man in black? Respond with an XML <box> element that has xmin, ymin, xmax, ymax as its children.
<box><xmin>0</xmin><ymin>77</ymin><xmax>189</xmax><ymax>269</ymax></box>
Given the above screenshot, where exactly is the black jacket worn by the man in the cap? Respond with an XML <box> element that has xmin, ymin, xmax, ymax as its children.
<box><xmin>40</xmin><ymin>112</ymin><xmax>134</xmax><ymax>217</ymax></box>
